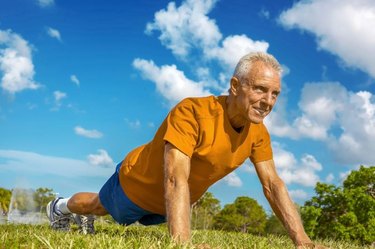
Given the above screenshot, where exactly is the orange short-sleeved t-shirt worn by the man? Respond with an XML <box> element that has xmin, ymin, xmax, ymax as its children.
<box><xmin>119</xmin><ymin>96</ymin><xmax>272</xmax><ymax>215</ymax></box>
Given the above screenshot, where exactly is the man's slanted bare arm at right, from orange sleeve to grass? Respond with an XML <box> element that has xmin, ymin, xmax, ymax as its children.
<box><xmin>255</xmin><ymin>160</ymin><xmax>316</xmax><ymax>248</ymax></box>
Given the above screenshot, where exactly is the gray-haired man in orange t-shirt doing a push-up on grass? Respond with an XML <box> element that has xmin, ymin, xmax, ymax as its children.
<box><xmin>48</xmin><ymin>53</ymin><xmax>326</xmax><ymax>248</ymax></box>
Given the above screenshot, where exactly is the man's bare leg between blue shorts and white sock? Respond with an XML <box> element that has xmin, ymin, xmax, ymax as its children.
<box><xmin>68</xmin><ymin>192</ymin><xmax>108</xmax><ymax>216</ymax></box>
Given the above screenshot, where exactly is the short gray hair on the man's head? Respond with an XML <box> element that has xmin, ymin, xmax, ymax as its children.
<box><xmin>233</xmin><ymin>52</ymin><xmax>282</xmax><ymax>81</ymax></box>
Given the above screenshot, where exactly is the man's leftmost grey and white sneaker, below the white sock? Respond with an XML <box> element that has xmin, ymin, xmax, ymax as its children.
<box><xmin>47</xmin><ymin>197</ymin><xmax>72</xmax><ymax>231</ymax></box>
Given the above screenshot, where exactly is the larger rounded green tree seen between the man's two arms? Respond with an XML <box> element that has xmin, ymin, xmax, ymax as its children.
<box><xmin>214</xmin><ymin>196</ymin><xmax>266</xmax><ymax>234</ymax></box>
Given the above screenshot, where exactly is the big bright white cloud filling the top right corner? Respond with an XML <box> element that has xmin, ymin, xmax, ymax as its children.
<box><xmin>279</xmin><ymin>0</ymin><xmax>375</xmax><ymax>78</ymax></box>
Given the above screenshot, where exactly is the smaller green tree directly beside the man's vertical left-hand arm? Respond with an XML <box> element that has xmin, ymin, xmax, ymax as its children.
<box><xmin>192</xmin><ymin>192</ymin><xmax>220</xmax><ymax>229</ymax></box>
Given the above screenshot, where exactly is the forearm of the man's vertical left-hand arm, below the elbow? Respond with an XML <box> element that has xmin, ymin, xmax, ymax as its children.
<box><xmin>165</xmin><ymin>178</ymin><xmax>190</xmax><ymax>242</ymax></box>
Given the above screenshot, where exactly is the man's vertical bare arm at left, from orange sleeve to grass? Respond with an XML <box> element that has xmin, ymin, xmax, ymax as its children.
<box><xmin>164</xmin><ymin>143</ymin><xmax>190</xmax><ymax>242</ymax></box>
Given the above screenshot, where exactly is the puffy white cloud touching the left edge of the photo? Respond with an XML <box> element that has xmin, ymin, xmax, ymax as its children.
<box><xmin>0</xmin><ymin>30</ymin><xmax>40</xmax><ymax>94</ymax></box>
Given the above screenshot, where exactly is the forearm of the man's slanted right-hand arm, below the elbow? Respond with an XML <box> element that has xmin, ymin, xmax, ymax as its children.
<box><xmin>264</xmin><ymin>178</ymin><xmax>311</xmax><ymax>245</ymax></box>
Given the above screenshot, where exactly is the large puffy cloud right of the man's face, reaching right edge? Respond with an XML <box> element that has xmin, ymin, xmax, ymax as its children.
<box><xmin>266</xmin><ymin>82</ymin><xmax>375</xmax><ymax>165</ymax></box>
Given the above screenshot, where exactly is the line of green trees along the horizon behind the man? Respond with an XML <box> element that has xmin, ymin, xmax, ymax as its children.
<box><xmin>0</xmin><ymin>166</ymin><xmax>375</xmax><ymax>244</ymax></box>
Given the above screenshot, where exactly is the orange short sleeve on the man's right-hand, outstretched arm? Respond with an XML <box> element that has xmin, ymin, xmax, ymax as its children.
<box><xmin>250</xmin><ymin>124</ymin><xmax>273</xmax><ymax>164</ymax></box>
